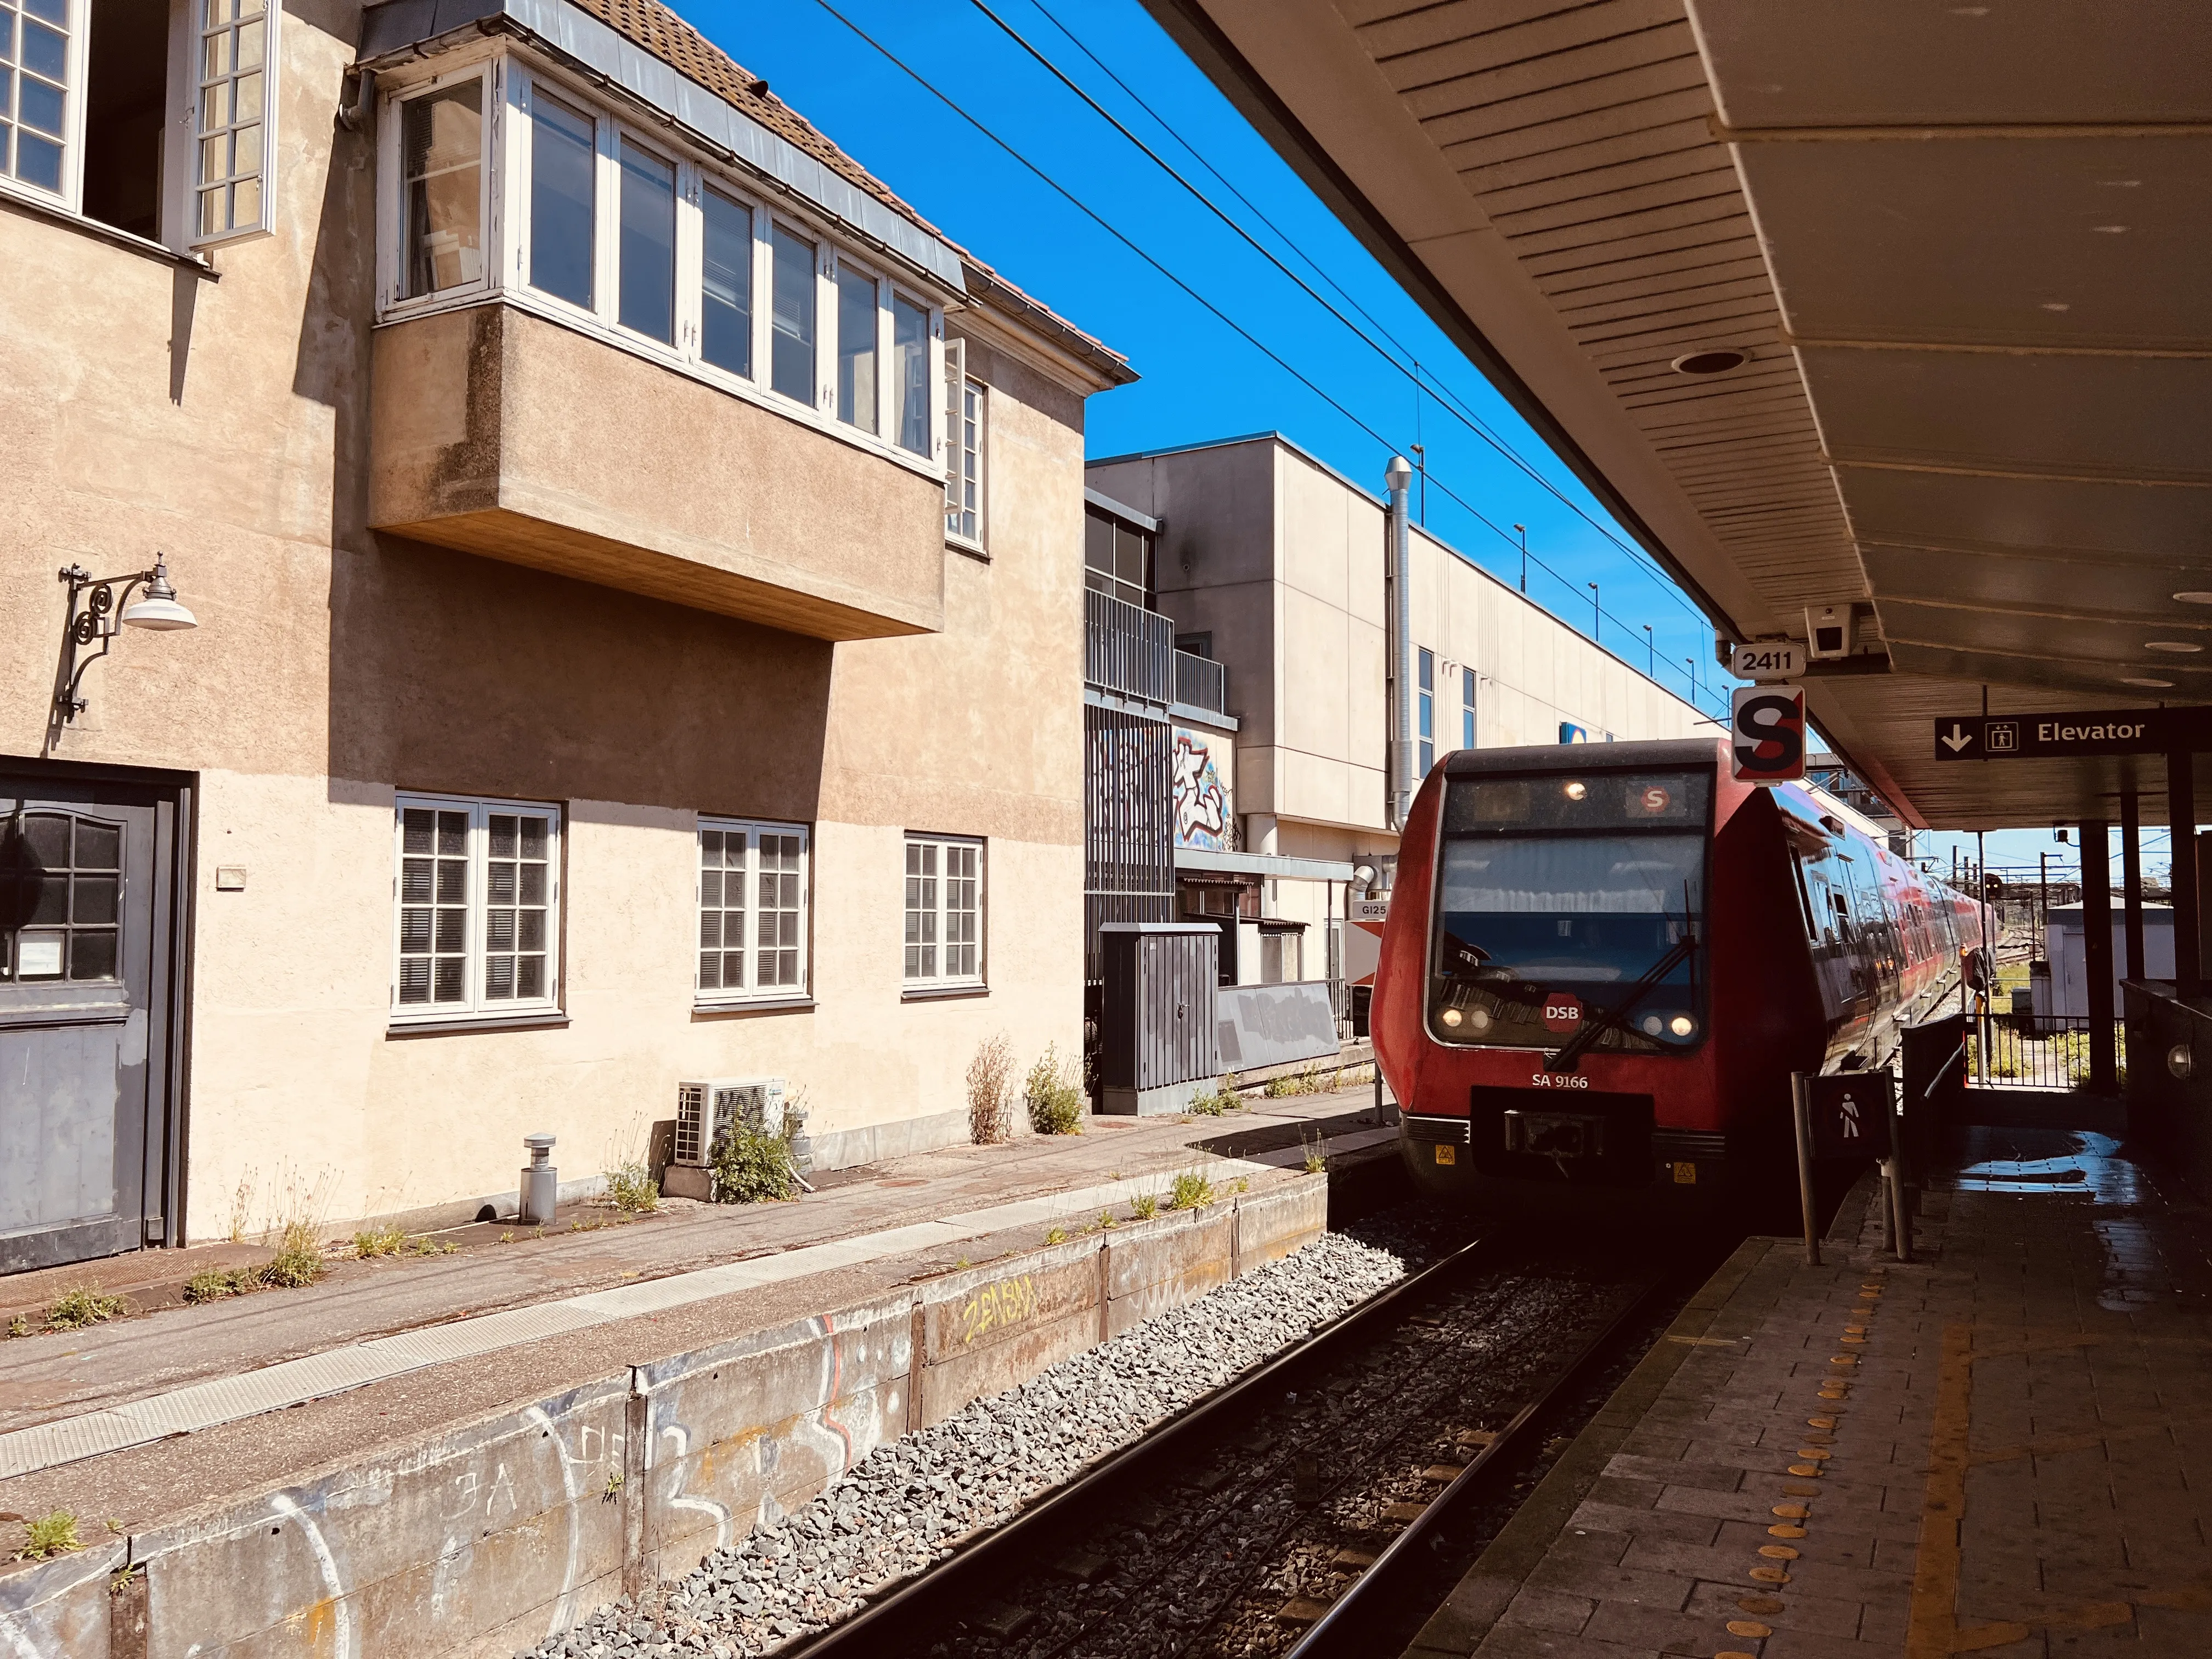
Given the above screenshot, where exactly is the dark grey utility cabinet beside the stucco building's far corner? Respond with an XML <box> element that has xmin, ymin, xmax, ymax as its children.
<box><xmin>1099</xmin><ymin>922</ymin><xmax>1221</xmax><ymax>1117</ymax></box>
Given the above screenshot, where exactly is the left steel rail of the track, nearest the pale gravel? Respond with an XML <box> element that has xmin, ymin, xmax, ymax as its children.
<box><xmin>781</xmin><ymin>1234</ymin><xmax>1500</xmax><ymax>1659</ymax></box>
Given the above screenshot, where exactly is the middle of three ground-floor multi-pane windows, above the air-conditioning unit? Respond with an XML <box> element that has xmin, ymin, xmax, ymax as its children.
<box><xmin>697</xmin><ymin>819</ymin><xmax>808</xmax><ymax>1002</ymax></box>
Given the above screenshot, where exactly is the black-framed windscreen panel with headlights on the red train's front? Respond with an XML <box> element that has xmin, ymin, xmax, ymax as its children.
<box><xmin>1429</xmin><ymin>774</ymin><xmax>1710</xmax><ymax>1053</ymax></box>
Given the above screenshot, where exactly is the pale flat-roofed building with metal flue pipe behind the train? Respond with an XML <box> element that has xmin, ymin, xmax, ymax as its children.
<box><xmin>1086</xmin><ymin>433</ymin><xmax>1714</xmax><ymax>984</ymax></box>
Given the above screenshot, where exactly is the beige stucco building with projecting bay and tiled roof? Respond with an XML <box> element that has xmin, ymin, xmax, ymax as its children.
<box><xmin>0</xmin><ymin>0</ymin><xmax>1132</xmax><ymax>1269</ymax></box>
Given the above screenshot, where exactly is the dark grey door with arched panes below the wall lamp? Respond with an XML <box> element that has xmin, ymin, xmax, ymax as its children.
<box><xmin>0</xmin><ymin>770</ymin><xmax>184</xmax><ymax>1272</ymax></box>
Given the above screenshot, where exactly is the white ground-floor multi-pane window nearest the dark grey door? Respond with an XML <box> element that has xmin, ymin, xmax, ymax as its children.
<box><xmin>392</xmin><ymin>797</ymin><xmax>560</xmax><ymax>1020</ymax></box>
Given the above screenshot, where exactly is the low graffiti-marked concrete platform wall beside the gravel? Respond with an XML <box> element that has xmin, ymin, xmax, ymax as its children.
<box><xmin>0</xmin><ymin>1177</ymin><xmax>1327</xmax><ymax>1659</ymax></box>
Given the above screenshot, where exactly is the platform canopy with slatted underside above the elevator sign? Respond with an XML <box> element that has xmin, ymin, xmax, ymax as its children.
<box><xmin>1148</xmin><ymin>0</ymin><xmax>2212</xmax><ymax>827</ymax></box>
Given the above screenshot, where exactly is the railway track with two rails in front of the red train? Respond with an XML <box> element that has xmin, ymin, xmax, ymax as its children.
<box><xmin>787</xmin><ymin>1237</ymin><xmax>1685</xmax><ymax>1659</ymax></box>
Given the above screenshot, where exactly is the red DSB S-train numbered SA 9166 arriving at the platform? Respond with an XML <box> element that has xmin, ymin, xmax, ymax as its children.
<box><xmin>1369</xmin><ymin>739</ymin><xmax>1982</xmax><ymax>1210</ymax></box>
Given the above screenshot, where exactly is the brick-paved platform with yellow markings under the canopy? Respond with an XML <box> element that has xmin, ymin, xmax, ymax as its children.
<box><xmin>1409</xmin><ymin>1130</ymin><xmax>2212</xmax><ymax>1659</ymax></box>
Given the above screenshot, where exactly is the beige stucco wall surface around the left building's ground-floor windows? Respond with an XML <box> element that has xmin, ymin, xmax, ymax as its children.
<box><xmin>0</xmin><ymin>0</ymin><xmax>1106</xmax><ymax>1239</ymax></box>
